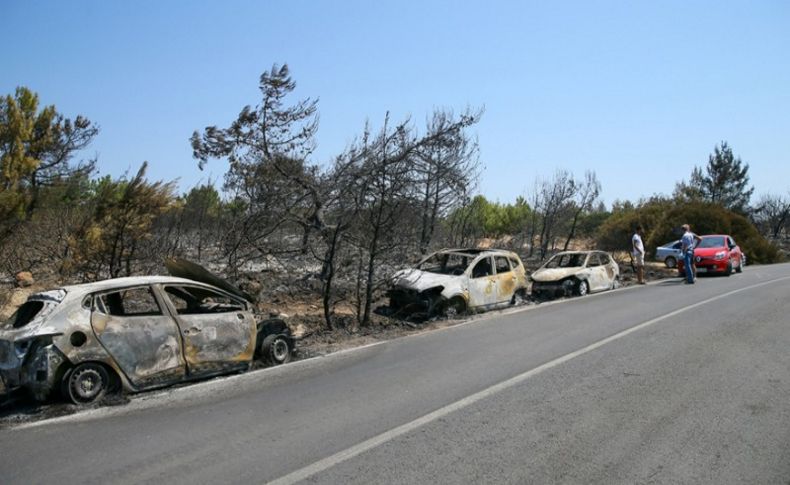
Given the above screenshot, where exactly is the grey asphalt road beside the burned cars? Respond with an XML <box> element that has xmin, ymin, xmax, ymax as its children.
<box><xmin>0</xmin><ymin>264</ymin><xmax>790</xmax><ymax>484</ymax></box>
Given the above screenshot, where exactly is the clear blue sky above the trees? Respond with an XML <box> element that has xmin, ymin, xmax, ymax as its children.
<box><xmin>0</xmin><ymin>0</ymin><xmax>790</xmax><ymax>203</ymax></box>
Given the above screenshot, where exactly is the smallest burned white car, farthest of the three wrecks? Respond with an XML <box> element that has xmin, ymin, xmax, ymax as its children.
<box><xmin>530</xmin><ymin>251</ymin><xmax>620</xmax><ymax>298</ymax></box>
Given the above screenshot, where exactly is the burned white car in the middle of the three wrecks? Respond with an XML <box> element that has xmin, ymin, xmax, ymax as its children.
<box><xmin>387</xmin><ymin>249</ymin><xmax>527</xmax><ymax>316</ymax></box>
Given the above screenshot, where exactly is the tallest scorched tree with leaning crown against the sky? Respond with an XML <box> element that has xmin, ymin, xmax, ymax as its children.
<box><xmin>191</xmin><ymin>65</ymin><xmax>324</xmax><ymax>271</ymax></box>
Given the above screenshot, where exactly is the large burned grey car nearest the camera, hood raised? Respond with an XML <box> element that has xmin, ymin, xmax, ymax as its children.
<box><xmin>0</xmin><ymin>276</ymin><xmax>294</xmax><ymax>404</ymax></box>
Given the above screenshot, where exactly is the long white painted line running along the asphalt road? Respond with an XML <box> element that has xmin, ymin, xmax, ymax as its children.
<box><xmin>269</xmin><ymin>276</ymin><xmax>790</xmax><ymax>485</ymax></box>
